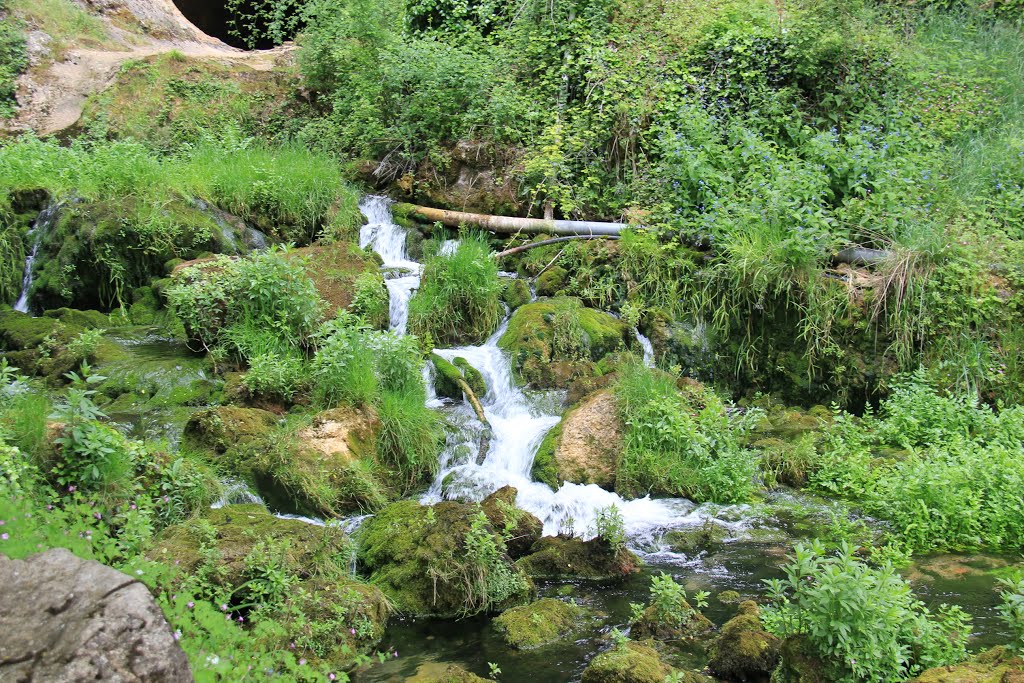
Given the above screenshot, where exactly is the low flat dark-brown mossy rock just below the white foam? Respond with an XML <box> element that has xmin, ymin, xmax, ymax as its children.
<box><xmin>516</xmin><ymin>536</ymin><xmax>641</xmax><ymax>581</ymax></box>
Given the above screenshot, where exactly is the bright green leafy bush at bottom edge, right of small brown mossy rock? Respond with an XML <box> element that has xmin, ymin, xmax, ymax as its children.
<box><xmin>763</xmin><ymin>543</ymin><xmax>970</xmax><ymax>682</ymax></box>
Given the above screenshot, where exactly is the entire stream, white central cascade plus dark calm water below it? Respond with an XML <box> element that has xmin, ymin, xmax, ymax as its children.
<box><xmin>356</xmin><ymin>197</ymin><xmax>1019</xmax><ymax>682</ymax></box>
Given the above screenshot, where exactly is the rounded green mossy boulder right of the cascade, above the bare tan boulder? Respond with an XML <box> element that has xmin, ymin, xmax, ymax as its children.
<box><xmin>498</xmin><ymin>297</ymin><xmax>631</xmax><ymax>388</ymax></box>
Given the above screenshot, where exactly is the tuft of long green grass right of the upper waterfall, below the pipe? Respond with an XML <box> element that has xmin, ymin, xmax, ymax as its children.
<box><xmin>409</xmin><ymin>236</ymin><xmax>504</xmax><ymax>345</ymax></box>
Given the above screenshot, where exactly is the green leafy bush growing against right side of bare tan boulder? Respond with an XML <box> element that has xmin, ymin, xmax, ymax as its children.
<box><xmin>615</xmin><ymin>361</ymin><xmax>757</xmax><ymax>503</ymax></box>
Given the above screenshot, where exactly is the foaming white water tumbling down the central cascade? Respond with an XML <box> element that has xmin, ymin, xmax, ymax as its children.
<box><xmin>359</xmin><ymin>197</ymin><xmax>745</xmax><ymax>552</ymax></box>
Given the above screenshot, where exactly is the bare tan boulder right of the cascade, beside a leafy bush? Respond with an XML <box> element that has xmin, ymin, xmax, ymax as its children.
<box><xmin>534</xmin><ymin>389</ymin><xmax>625</xmax><ymax>490</ymax></box>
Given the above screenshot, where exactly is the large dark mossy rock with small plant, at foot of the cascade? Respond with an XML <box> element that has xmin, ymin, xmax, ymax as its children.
<box><xmin>357</xmin><ymin>501</ymin><xmax>534</xmax><ymax>617</ymax></box>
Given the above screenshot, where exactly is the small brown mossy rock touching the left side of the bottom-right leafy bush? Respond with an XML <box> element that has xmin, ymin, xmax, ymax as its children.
<box><xmin>708</xmin><ymin>601</ymin><xmax>781</xmax><ymax>681</ymax></box>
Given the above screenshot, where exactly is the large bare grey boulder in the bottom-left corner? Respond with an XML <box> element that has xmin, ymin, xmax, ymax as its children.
<box><xmin>0</xmin><ymin>548</ymin><xmax>193</xmax><ymax>683</ymax></box>
